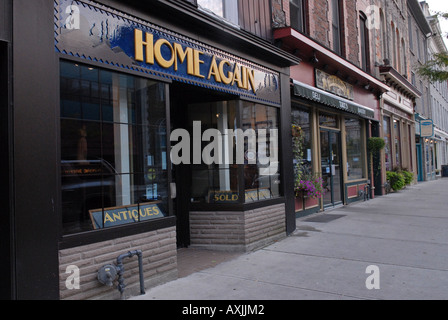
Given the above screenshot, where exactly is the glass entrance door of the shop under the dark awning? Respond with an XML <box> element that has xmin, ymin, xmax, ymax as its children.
<box><xmin>320</xmin><ymin>129</ymin><xmax>342</xmax><ymax>207</ymax></box>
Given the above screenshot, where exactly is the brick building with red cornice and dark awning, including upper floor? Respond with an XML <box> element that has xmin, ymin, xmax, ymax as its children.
<box><xmin>274</xmin><ymin>0</ymin><xmax>389</xmax><ymax>216</ymax></box>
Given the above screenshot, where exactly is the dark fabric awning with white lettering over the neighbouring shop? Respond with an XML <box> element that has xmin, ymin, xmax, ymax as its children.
<box><xmin>293</xmin><ymin>80</ymin><xmax>375</xmax><ymax>119</ymax></box>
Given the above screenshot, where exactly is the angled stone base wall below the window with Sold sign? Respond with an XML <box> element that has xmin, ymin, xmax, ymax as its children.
<box><xmin>190</xmin><ymin>204</ymin><xmax>286</xmax><ymax>252</ymax></box>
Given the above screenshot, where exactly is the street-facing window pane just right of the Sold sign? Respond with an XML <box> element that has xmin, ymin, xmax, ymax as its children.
<box><xmin>241</xmin><ymin>102</ymin><xmax>280</xmax><ymax>202</ymax></box>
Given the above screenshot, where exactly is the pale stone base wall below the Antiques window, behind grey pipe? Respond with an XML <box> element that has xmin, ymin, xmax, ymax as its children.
<box><xmin>59</xmin><ymin>227</ymin><xmax>178</xmax><ymax>300</ymax></box>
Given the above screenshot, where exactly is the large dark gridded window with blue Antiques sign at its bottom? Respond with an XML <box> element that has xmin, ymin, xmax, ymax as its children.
<box><xmin>60</xmin><ymin>62</ymin><xmax>168</xmax><ymax>234</ymax></box>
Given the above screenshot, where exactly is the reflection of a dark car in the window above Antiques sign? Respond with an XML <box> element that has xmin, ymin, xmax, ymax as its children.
<box><xmin>61</xmin><ymin>159</ymin><xmax>115</xmax><ymax>230</ymax></box>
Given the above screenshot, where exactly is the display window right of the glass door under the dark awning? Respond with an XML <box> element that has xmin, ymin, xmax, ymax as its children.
<box><xmin>345</xmin><ymin>119</ymin><xmax>365</xmax><ymax>180</ymax></box>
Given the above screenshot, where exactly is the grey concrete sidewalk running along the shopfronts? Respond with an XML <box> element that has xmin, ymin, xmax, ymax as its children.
<box><xmin>133</xmin><ymin>179</ymin><xmax>448</xmax><ymax>300</ymax></box>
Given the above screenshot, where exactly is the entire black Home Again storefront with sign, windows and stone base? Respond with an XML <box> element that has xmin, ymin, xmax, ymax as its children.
<box><xmin>2</xmin><ymin>0</ymin><xmax>300</xmax><ymax>299</ymax></box>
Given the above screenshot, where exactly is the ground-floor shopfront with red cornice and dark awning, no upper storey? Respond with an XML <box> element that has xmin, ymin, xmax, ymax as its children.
<box><xmin>275</xmin><ymin>28</ymin><xmax>388</xmax><ymax>217</ymax></box>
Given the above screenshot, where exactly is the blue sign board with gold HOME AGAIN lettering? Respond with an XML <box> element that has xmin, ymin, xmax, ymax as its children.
<box><xmin>55</xmin><ymin>0</ymin><xmax>281</xmax><ymax>105</ymax></box>
